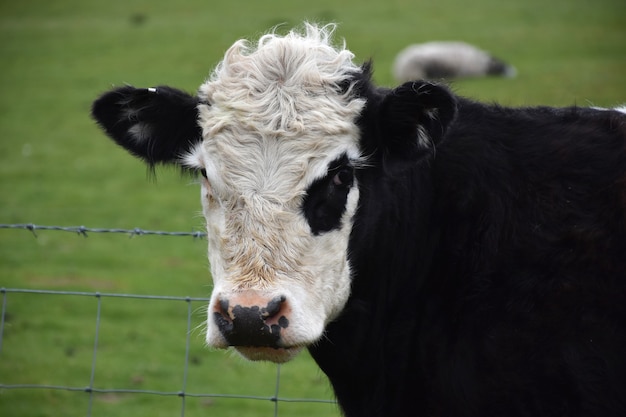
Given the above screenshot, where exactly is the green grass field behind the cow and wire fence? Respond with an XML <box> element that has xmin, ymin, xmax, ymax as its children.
<box><xmin>0</xmin><ymin>0</ymin><xmax>626</xmax><ymax>417</ymax></box>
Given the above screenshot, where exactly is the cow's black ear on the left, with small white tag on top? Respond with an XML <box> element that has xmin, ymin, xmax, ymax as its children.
<box><xmin>91</xmin><ymin>86</ymin><xmax>202</xmax><ymax>166</ymax></box>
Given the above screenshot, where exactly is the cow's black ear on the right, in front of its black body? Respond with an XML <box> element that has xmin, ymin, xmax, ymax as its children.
<box><xmin>379</xmin><ymin>81</ymin><xmax>457</xmax><ymax>160</ymax></box>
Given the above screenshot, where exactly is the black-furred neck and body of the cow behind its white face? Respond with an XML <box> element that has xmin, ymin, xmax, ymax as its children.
<box><xmin>310</xmin><ymin>85</ymin><xmax>626</xmax><ymax>417</ymax></box>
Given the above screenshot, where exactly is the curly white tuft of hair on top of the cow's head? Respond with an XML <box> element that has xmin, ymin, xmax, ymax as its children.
<box><xmin>198</xmin><ymin>23</ymin><xmax>363</xmax><ymax>136</ymax></box>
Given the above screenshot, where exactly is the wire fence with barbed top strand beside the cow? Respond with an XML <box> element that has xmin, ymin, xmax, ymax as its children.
<box><xmin>0</xmin><ymin>223</ymin><xmax>336</xmax><ymax>417</ymax></box>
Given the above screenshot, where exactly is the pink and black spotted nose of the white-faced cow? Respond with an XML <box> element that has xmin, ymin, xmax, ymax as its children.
<box><xmin>213</xmin><ymin>293</ymin><xmax>289</xmax><ymax>347</ymax></box>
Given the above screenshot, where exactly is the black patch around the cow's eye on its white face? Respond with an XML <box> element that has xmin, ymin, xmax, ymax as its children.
<box><xmin>302</xmin><ymin>155</ymin><xmax>354</xmax><ymax>235</ymax></box>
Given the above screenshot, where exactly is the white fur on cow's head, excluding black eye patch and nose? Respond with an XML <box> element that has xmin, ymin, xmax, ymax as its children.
<box><xmin>186</xmin><ymin>25</ymin><xmax>364</xmax><ymax>362</ymax></box>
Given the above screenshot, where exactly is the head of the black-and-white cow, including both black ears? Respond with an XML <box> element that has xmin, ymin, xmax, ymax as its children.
<box><xmin>93</xmin><ymin>25</ymin><xmax>455</xmax><ymax>362</ymax></box>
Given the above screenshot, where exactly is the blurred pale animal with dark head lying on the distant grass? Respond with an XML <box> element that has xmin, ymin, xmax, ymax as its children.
<box><xmin>392</xmin><ymin>41</ymin><xmax>517</xmax><ymax>82</ymax></box>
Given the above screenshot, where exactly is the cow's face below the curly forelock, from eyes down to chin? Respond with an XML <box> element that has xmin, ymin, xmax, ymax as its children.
<box><xmin>190</xmin><ymin>113</ymin><xmax>360</xmax><ymax>361</ymax></box>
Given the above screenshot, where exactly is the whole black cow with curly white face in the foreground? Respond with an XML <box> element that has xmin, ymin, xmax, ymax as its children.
<box><xmin>93</xmin><ymin>25</ymin><xmax>626</xmax><ymax>417</ymax></box>
